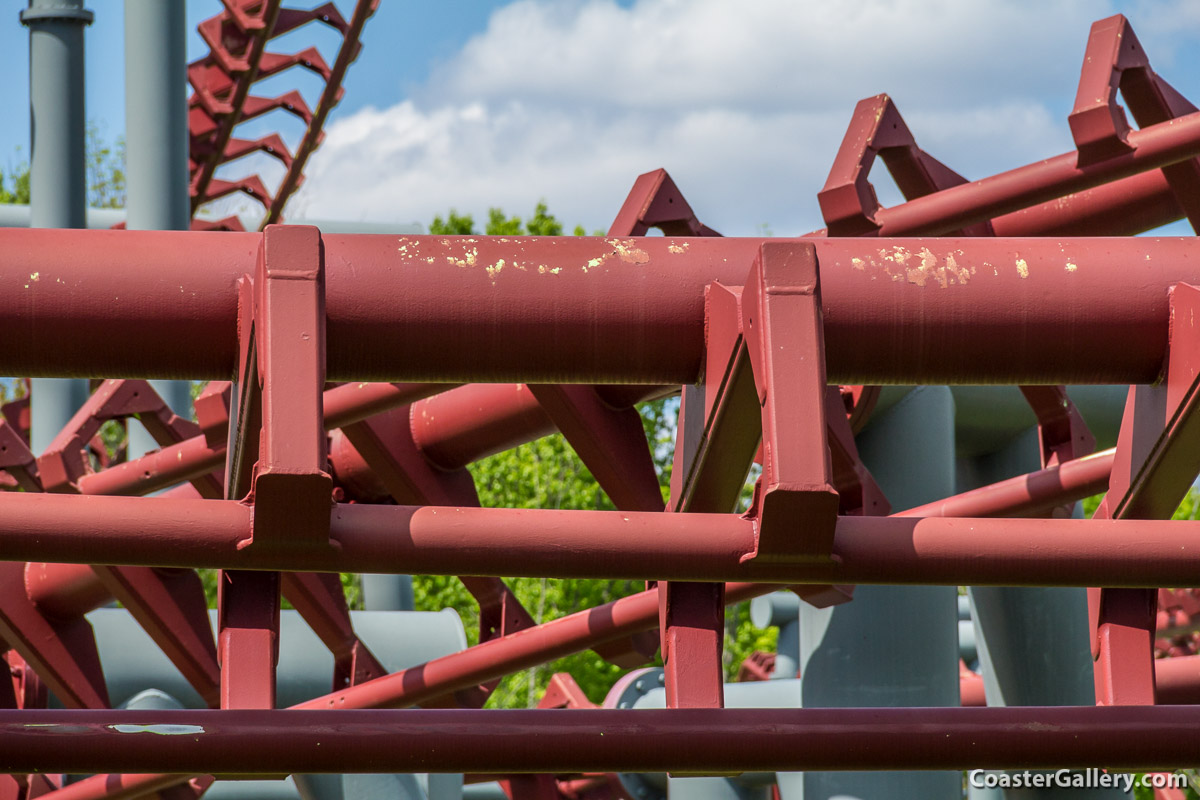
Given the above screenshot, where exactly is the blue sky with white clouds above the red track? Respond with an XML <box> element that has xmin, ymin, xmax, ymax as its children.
<box><xmin>0</xmin><ymin>0</ymin><xmax>1200</xmax><ymax>235</ymax></box>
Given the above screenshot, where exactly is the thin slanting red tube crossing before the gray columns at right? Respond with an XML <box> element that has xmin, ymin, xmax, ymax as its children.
<box><xmin>893</xmin><ymin>450</ymin><xmax>1116</xmax><ymax>517</ymax></box>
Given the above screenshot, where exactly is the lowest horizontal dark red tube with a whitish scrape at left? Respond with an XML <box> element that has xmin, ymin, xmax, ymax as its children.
<box><xmin>7</xmin><ymin>705</ymin><xmax>1200</xmax><ymax>775</ymax></box>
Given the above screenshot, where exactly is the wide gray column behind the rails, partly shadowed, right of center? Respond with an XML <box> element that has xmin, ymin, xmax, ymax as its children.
<box><xmin>779</xmin><ymin>386</ymin><xmax>962</xmax><ymax>800</ymax></box>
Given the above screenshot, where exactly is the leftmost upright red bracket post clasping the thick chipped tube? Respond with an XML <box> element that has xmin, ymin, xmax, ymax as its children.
<box><xmin>217</xmin><ymin>225</ymin><xmax>332</xmax><ymax>708</ymax></box>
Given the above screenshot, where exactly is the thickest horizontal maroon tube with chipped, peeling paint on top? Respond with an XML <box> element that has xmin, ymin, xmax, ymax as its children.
<box><xmin>7</xmin><ymin>230</ymin><xmax>1200</xmax><ymax>385</ymax></box>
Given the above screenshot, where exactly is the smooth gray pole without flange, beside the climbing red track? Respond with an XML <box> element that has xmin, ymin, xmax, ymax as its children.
<box><xmin>125</xmin><ymin>0</ymin><xmax>192</xmax><ymax>458</ymax></box>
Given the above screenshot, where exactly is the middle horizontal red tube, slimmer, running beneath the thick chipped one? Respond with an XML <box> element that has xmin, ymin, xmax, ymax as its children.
<box><xmin>0</xmin><ymin>494</ymin><xmax>1200</xmax><ymax>587</ymax></box>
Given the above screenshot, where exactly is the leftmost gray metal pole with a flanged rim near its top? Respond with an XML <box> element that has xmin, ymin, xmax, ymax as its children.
<box><xmin>20</xmin><ymin>0</ymin><xmax>94</xmax><ymax>453</ymax></box>
